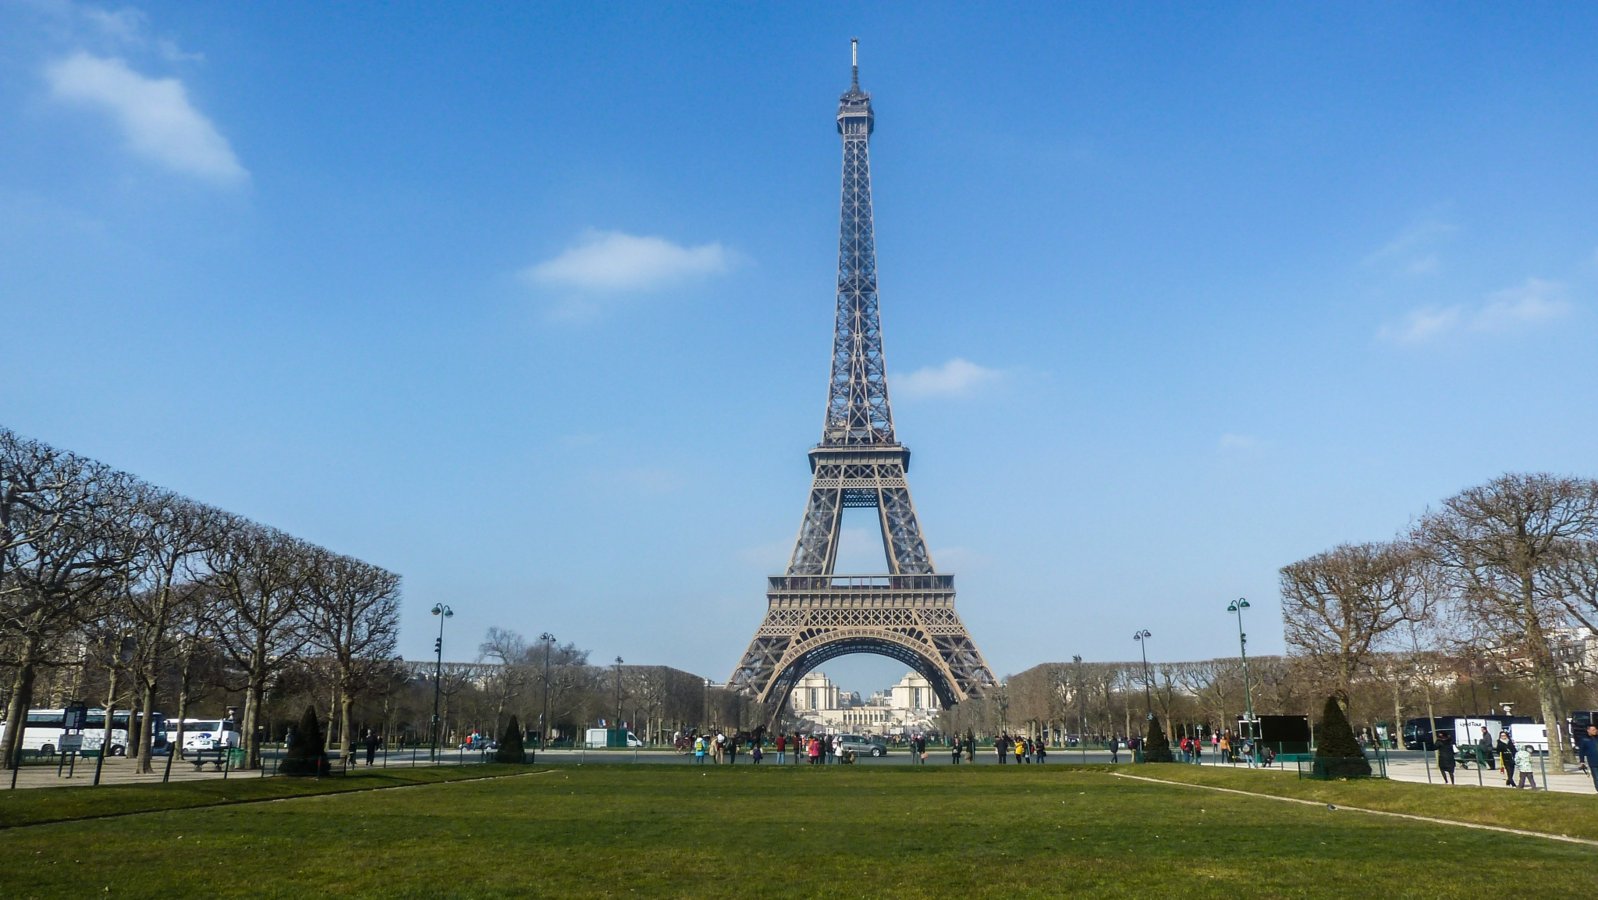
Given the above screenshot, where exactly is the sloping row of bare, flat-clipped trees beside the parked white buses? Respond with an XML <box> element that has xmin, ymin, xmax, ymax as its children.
<box><xmin>0</xmin><ymin>428</ymin><xmax>400</xmax><ymax>771</ymax></box>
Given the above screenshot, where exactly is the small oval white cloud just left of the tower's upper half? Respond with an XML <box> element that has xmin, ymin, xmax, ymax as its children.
<box><xmin>521</xmin><ymin>229</ymin><xmax>732</xmax><ymax>293</ymax></box>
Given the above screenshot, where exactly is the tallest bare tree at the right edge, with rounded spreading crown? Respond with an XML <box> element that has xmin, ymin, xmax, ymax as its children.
<box><xmin>1416</xmin><ymin>473</ymin><xmax>1598</xmax><ymax>767</ymax></box>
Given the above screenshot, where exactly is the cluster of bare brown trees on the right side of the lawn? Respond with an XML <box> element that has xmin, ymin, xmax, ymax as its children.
<box><xmin>1282</xmin><ymin>473</ymin><xmax>1598</xmax><ymax>766</ymax></box>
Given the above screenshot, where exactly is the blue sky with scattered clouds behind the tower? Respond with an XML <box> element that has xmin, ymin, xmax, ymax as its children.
<box><xmin>0</xmin><ymin>0</ymin><xmax>1598</xmax><ymax>691</ymax></box>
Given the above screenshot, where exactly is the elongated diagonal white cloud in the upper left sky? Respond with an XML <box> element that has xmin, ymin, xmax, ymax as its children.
<box><xmin>45</xmin><ymin>53</ymin><xmax>249</xmax><ymax>184</ymax></box>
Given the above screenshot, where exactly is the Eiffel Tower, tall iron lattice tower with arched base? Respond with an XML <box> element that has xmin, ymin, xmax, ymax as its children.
<box><xmin>727</xmin><ymin>42</ymin><xmax>994</xmax><ymax>719</ymax></box>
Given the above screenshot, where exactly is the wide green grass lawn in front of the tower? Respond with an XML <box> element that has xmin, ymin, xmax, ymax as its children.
<box><xmin>0</xmin><ymin>764</ymin><xmax>1598</xmax><ymax>898</ymax></box>
